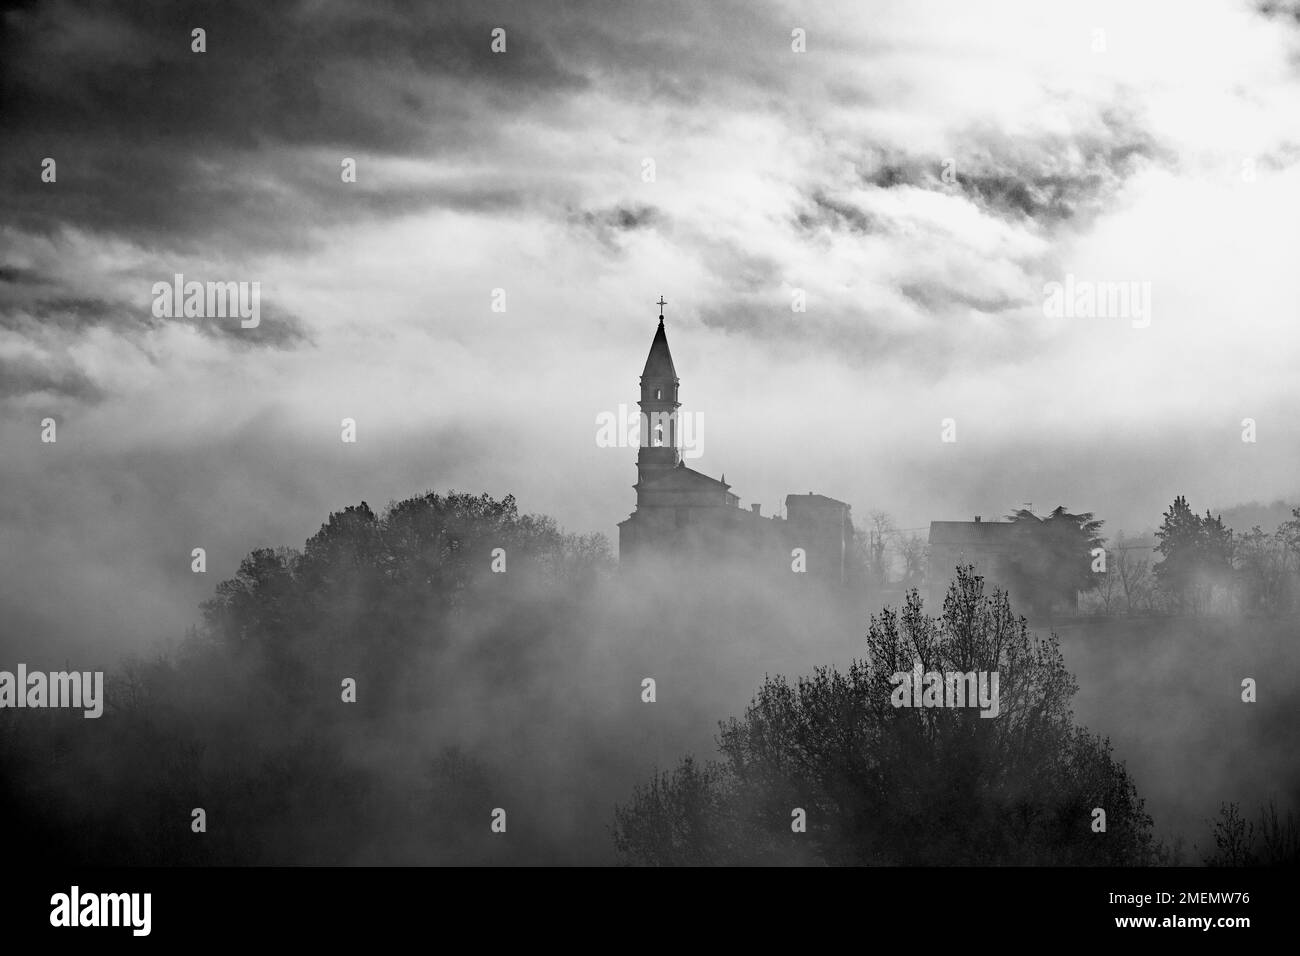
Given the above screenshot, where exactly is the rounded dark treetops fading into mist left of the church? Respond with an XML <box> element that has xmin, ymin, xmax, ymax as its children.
<box><xmin>203</xmin><ymin>493</ymin><xmax>614</xmax><ymax>706</ymax></box>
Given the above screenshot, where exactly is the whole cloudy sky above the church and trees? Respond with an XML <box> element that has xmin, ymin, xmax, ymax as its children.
<box><xmin>0</xmin><ymin>0</ymin><xmax>1300</xmax><ymax>658</ymax></box>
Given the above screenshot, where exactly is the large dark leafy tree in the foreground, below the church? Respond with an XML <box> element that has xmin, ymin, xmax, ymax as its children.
<box><xmin>615</xmin><ymin>568</ymin><xmax>1160</xmax><ymax>865</ymax></box>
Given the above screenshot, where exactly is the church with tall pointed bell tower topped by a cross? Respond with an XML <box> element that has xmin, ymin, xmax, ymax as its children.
<box><xmin>619</xmin><ymin>297</ymin><xmax>853</xmax><ymax>584</ymax></box>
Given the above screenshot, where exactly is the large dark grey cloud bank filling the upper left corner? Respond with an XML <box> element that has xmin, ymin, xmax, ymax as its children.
<box><xmin>0</xmin><ymin>3</ymin><xmax>588</xmax><ymax>248</ymax></box>
